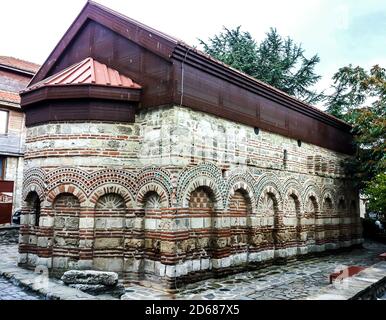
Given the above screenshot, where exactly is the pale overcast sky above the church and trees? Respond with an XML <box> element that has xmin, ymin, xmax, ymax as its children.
<box><xmin>0</xmin><ymin>0</ymin><xmax>386</xmax><ymax>104</ymax></box>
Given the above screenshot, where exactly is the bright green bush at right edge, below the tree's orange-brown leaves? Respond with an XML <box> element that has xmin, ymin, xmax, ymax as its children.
<box><xmin>364</xmin><ymin>173</ymin><xmax>386</xmax><ymax>213</ymax></box>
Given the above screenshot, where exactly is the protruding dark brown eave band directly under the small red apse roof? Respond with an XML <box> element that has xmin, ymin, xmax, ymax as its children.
<box><xmin>20</xmin><ymin>84</ymin><xmax>141</xmax><ymax>109</ymax></box>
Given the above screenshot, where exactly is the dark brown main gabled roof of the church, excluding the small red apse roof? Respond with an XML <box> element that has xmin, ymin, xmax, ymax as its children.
<box><xmin>21</xmin><ymin>1</ymin><xmax>352</xmax><ymax>153</ymax></box>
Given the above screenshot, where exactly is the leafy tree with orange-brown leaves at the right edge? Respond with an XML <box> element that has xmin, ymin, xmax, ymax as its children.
<box><xmin>327</xmin><ymin>65</ymin><xmax>386</xmax><ymax>210</ymax></box>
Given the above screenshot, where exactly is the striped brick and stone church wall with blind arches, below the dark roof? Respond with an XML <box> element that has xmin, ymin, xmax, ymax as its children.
<box><xmin>19</xmin><ymin>106</ymin><xmax>362</xmax><ymax>286</ymax></box>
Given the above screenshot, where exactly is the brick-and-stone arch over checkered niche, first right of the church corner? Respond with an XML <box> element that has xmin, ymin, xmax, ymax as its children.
<box><xmin>182</xmin><ymin>176</ymin><xmax>223</xmax><ymax>209</ymax></box>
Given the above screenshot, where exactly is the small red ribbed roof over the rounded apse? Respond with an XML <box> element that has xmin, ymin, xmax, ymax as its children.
<box><xmin>23</xmin><ymin>58</ymin><xmax>141</xmax><ymax>92</ymax></box>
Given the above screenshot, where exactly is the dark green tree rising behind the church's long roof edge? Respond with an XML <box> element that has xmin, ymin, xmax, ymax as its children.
<box><xmin>199</xmin><ymin>26</ymin><xmax>324</xmax><ymax>103</ymax></box>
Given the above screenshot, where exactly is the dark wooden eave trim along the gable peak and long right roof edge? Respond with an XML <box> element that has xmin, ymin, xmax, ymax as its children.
<box><xmin>30</xmin><ymin>1</ymin><xmax>351</xmax><ymax>132</ymax></box>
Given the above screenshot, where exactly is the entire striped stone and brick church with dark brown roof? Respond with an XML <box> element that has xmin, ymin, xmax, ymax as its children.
<box><xmin>19</xmin><ymin>1</ymin><xmax>362</xmax><ymax>287</ymax></box>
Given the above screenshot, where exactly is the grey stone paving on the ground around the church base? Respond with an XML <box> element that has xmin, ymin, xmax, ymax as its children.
<box><xmin>0</xmin><ymin>228</ymin><xmax>386</xmax><ymax>300</ymax></box>
